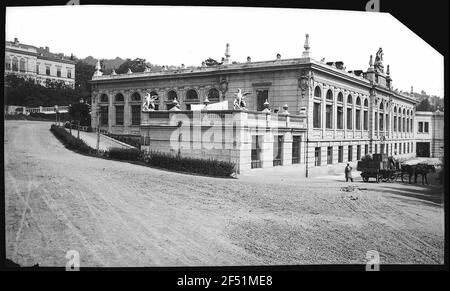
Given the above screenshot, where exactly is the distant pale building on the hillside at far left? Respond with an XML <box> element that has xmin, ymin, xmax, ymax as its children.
<box><xmin>5</xmin><ymin>38</ymin><xmax>75</xmax><ymax>88</ymax></box>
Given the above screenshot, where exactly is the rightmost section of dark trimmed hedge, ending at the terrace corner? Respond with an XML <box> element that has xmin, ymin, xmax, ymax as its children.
<box><xmin>144</xmin><ymin>152</ymin><xmax>235</xmax><ymax>177</ymax></box>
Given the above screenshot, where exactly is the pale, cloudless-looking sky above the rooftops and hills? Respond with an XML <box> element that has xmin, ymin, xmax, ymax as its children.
<box><xmin>5</xmin><ymin>5</ymin><xmax>444</xmax><ymax>97</ymax></box>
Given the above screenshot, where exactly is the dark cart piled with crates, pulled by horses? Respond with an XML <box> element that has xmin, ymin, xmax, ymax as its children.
<box><xmin>356</xmin><ymin>154</ymin><xmax>398</xmax><ymax>183</ymax></box>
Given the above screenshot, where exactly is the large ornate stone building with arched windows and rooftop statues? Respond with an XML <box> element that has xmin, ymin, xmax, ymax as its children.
<box><xmin>91</xmin><ymin>36</ymin><xmax>416</xmax><ymax>175</ymax></box>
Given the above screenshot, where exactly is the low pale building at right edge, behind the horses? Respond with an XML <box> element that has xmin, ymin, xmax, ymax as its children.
<box><xmin>415</xmin><ymin>111</ymin><xmax>445</xmax><ymax>158</ymax></box>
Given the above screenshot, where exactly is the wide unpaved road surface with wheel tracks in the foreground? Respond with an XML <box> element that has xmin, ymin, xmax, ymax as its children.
<box><xmin>5</xmin><ymin>121</ymin><xmax>444</xmax><ymax>267</ymax></box>
